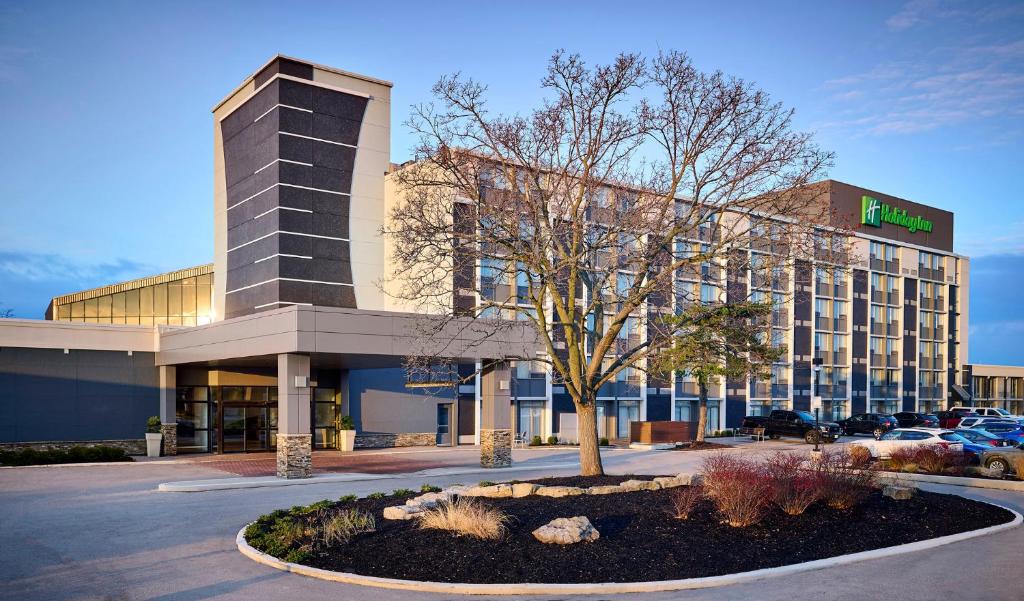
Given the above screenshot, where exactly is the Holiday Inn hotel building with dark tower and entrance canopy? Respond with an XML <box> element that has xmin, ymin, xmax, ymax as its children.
<box><xmin>0</xmin><ymin>56</ymin><xmax>1007</xmax><ymax>475</ymax></box>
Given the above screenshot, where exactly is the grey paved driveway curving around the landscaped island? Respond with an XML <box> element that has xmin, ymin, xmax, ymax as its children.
<box><xmin>0</xmin><ymin>444</ymin><xmax>1024</xmax><ymax>601</ymax></box>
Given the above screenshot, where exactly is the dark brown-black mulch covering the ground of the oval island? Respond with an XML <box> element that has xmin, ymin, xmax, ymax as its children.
<box><xmin>272</xmin><ymin>476</ymin><xmax>1013</xmax><ymax>583</ymax></box>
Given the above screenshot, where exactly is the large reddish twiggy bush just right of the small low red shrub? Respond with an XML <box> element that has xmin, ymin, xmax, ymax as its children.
<box><xmin>700</xmin><ymin>454</ymin><xmax>771</xmax><ymax>527</ymax></box>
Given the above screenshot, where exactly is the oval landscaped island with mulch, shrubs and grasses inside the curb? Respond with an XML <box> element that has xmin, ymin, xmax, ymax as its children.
<box><xmin>246</xmin><ymin>452</ymin><xmax>1014</xmax><ymax>584</ymax></box>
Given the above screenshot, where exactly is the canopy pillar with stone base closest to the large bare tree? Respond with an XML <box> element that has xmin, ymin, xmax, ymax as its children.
<box><xmin>480</xmin><ymin>361</ymin><xmax>512</xmax><ymax>468</ymax></box>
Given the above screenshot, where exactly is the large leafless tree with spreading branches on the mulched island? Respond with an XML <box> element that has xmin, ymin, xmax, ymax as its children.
<box><xmin>383</xmin><ymin>51</ymin><xmax>833</xmax><ymax>475</ymax></box>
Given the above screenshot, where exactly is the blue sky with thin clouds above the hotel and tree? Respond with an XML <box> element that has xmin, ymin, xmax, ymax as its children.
<box><xmin>0</xmin><ymin>0</ymin><xmax>1024</xmax><ymax>364</ymax></box>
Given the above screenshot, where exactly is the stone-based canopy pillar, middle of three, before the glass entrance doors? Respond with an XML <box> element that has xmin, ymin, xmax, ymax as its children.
<box><xmin>278</xmin><ymin>354</ymin><xmax>312</xmax><ymax>478</ymax></box>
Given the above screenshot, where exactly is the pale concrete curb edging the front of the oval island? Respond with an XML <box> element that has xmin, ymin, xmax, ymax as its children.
<box><xmin>234</xmin><ymin>500</ymin><xmax>1024</xmax><ymax>595</ymax></box>
